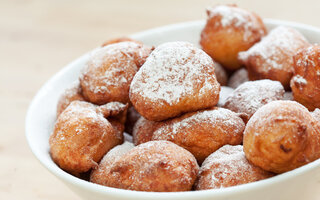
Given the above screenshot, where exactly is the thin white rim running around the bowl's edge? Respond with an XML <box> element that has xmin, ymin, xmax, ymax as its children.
<box><xmin>25</xmin><ymin>19</ymin><xmax>320</xmax><ymax>199</ymax></box>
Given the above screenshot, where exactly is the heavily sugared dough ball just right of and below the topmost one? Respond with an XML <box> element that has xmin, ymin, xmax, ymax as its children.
<box><xmin>238</xmin><ymin>26</ymin><xmax>309</xmax><ymax>89</ymax></box>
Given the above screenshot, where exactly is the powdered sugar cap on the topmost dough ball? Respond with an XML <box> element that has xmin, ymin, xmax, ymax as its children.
<box><xmin>207</xmin><ymin>5</ymin><xmax>265</xmax><ymax>41</ymax></box>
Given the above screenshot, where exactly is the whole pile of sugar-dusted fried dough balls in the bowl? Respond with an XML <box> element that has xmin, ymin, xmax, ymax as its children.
<box><xmin>49</xmin><ymin>5</ymin><xmax>320</xmax><ymax>192</ymax></box>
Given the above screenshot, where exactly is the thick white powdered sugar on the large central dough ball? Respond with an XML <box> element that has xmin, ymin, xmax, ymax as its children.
<box><xmin>131</xmin><ymin>42</ymin><xmax>214</xmax><ymax>105</ymax></box>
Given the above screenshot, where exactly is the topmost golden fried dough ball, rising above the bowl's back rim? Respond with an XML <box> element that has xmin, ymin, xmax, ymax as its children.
<box><xmin>200</xmin><ymin>5</ymin><xmax>267</xmax><ymax>70</ymax></box>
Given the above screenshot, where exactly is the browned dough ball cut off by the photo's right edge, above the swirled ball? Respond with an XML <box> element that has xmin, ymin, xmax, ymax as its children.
<box><xmin>290</xmin><ymin>44</ymin><xmax>320</xmax><ymax>111</ymax></box>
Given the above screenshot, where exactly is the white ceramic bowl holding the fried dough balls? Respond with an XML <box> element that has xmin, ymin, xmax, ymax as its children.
<box><xmin>26</xmin><ymin>20</ymin><xmax>320</xmax><ymax>200</ymax></box>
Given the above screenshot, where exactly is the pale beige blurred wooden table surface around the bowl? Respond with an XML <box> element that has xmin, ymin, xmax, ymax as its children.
<box><xmin>0</xmin><ymin>0</ymin><xmax>320</xmax><ymax>200</ymax></box>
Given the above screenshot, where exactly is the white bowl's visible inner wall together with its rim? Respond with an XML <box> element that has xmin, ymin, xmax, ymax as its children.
<box><xmin>26</xmin><ymin>20</ymin><xmax>320</xmax><ymax>198</ymax></box>
